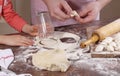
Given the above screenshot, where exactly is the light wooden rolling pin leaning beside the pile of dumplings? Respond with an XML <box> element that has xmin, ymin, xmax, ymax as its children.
<box><xmin>80</xmin><ymin>18</ymin><xmax>120</xmax><ymax>48</ymax></box>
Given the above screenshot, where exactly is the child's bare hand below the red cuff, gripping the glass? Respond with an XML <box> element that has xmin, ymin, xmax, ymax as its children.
<box><xmin>22</xmin><ymin>24</ymin><xmax>38</xmax><ymax>36</ymax></box>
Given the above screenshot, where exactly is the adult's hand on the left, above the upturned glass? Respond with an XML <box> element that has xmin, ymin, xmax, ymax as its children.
<box><xmin>43</xmin><ymin>0</ymin><xmax>72</xmax><ymax>21</ymax></box>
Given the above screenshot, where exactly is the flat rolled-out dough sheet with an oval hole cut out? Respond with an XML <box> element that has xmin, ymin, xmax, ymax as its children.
<box><xmin>34</xmin><ymin>31</ymin><xmax>80</xmax><ymax>51</ymax></box>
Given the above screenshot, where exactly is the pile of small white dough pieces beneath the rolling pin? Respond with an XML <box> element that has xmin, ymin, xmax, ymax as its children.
<box><xmin>95</xmin><ymin>32</ymin><xmax>120</xmax><ymax>52</ymax></box>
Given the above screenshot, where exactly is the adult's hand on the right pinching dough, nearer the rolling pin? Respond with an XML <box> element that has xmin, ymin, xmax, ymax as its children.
<box><xmin>76</xmin><ymin>1</ymin><xmax>101</xmax><ymax>23</ymax></box>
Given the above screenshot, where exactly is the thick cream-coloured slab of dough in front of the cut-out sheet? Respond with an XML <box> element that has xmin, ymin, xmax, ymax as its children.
<box><xmin>32</xmin><ymin>50</ymin><xmax>70</xmax><ymax>72</ymax></box>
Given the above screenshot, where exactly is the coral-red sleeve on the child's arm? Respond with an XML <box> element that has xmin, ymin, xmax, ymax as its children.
<box><xmin>2</xmin><ymin>0</ymin><xmax>27</xmax><ymax>32</ymax></box>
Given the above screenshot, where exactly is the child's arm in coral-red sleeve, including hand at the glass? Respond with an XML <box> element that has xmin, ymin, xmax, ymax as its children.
<box><xmin>2</xmin><ymin>0</ymin><xmax>38</xmax><ymax>35</ymax></box>
